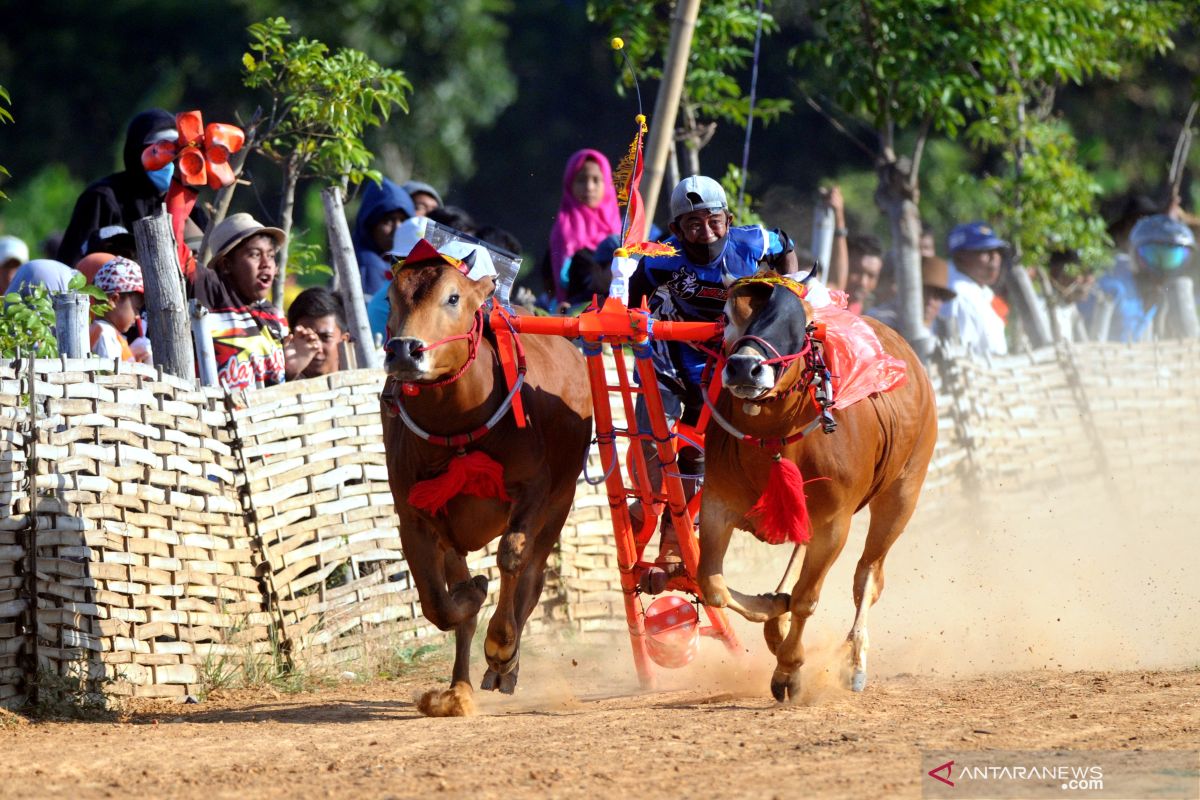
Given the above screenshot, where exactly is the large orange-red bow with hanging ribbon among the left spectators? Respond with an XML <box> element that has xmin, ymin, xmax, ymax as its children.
<box><xmin>142</xmin><ymin>112</ymin><xmax>246</xmax><ymax>275</ymax></box>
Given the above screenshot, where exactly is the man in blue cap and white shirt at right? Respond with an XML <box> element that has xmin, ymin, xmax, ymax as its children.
<box><xmin>941</xmin><ymin>222</ymin><xmax>1008</xmax><ymax>355</ymax></box>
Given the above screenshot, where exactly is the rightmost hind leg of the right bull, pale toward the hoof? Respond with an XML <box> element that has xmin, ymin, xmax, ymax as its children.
<box><xmin>846</xmin><ymin>479</ymin><xmax>920</xmax><ymax>692</ymax></box>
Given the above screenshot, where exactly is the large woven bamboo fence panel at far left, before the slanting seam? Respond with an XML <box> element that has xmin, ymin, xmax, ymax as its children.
<box><xmin>20</xmin><ymin>359</ymin><xmax>260</xmax><ymax>697</ymax></box>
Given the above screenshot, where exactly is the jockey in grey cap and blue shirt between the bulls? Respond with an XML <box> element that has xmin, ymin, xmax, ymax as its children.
<box><xmin>629</xmin><ymin>175</ymin><xmax>799</xmax><ymax>582</ymax></box>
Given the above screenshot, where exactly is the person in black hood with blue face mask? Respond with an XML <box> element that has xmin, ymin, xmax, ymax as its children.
<box><xmin>58</xmin><ymin>108</ymin><xmax>209</xmax><ymax>264</ymax></box>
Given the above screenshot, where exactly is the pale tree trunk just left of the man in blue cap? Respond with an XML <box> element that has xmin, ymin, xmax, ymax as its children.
<box><xmin>875</xmin><ymin>162</ymin><xmax>934</xmax><ymax>359</ymax></box>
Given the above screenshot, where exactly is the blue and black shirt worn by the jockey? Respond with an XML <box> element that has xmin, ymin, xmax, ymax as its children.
<box><xmin>629</xmin><ymin>225</ymin><xmax>786</xmax><ymax>393</ymax></box>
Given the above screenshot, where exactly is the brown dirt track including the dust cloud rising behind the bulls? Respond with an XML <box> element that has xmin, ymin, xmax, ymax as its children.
<box><xmin>0</xmin><ymin>476</ymin><xmax>1200</xmax><ymax>800</ymax></box>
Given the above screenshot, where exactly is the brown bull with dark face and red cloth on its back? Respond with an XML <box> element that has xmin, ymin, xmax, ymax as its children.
<box><xmin>698</xmin><ymin>278</ymin><xmax>937</xmax><ymax>700</ymax></box>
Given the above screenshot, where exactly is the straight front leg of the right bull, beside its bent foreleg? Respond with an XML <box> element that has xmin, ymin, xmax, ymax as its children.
<box><xmin>770</xmin><ymin>515</ymin><xmax>851</xmax><ymax>702</ymax></box>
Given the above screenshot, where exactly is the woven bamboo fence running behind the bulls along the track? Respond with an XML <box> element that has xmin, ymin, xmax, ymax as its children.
<box><xmin>0</xmin><ymin>341</ymin><xmax>1200</xmax><ymax>706</ymax></box>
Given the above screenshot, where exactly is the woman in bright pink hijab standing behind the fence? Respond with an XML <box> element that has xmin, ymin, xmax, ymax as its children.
<box><xmin>550</xmin><ymin>150</ymin><xmax>620</xmax><ymax>303</ymax></box>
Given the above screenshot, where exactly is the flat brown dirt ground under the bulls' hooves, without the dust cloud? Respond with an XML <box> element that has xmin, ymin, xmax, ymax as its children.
<box><xmin>0</xmin><ymin>670</ymin><xmax>1200</xmax><ymax>798</ymax></box>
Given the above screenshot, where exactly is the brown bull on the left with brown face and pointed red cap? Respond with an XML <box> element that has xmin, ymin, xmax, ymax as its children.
<box><xmin>383</xmin><ymin>251</ymin><xmax>592</xmax><ymax>715</ymax></box>
